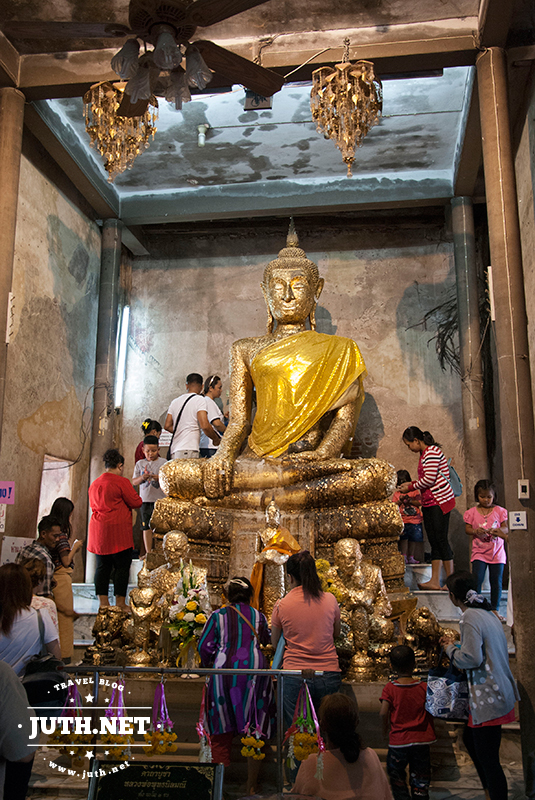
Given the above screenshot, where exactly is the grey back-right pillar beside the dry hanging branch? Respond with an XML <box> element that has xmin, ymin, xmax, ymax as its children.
<box><xmin>451</xmin><ymin>197</ymin><xmax>489</xmax><ymax>490</ymax></box>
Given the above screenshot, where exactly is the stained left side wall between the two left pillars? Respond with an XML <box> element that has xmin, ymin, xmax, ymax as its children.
<box><xmin>0</xmin><ymin>152</ymin><xmax>100</xmax><ymax>564</ymax></box>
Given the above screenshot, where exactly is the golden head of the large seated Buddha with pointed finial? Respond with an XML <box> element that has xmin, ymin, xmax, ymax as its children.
<box><xmin>261</xmin><ymin>220</ymin><xmax>324</xmax><ymax>333</ymax></box>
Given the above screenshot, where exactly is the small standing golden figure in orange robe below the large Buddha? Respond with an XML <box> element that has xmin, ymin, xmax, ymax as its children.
<box><xmin>251</xmin><ymin>500</ymin><xmax>301</xmax><ymax>623</ymax></box>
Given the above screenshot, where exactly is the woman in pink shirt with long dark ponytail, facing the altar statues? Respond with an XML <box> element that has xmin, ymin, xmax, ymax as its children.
<box><xmin>271</xmin><ymin>550</ymin><xmax>341</xmax><ymax>728</ymax></box>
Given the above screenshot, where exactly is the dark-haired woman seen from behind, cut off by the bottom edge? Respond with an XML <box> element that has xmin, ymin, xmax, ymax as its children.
<box><xmin>292</xmin><ymin>694</ymin><xmax>392</xmax><ymax>800</ymax></box>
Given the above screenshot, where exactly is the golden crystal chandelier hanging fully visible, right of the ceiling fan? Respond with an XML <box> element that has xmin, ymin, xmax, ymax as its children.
<box><xmin>310</xmin><ymin>39</ymin><xmax>383</xmax><ymax>178</ymax></box>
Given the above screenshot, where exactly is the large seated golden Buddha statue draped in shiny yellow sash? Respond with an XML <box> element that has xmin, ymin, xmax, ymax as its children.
<box><xmin>152</xmin><ymin>226</ymin><xmax>404</xmax><ymax>586</ymax></box>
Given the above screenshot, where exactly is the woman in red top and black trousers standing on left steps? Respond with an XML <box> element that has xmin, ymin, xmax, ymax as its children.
<box><xmin>87</xmin><ymin>450</ymin><xmax>142</xmax><ymax>611</ymax></box>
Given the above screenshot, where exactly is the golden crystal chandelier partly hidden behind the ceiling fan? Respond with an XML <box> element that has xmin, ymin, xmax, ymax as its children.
<box><xmin>84</xmin><ymin>81</ymin><xmax>158</xmax><ymax>183</ymax></box>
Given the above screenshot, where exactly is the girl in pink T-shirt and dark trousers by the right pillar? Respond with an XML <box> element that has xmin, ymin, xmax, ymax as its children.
<box><xmin>463</xmin><ymin>481</ymin><xmax>509</xmax><ymax>622</ymax></box>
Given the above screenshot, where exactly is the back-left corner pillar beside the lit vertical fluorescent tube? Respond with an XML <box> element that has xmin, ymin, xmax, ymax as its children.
<box><xmin>85</xmin><ymin>219</ymin><xmax>122</xmax><ymax>582</ymax></box>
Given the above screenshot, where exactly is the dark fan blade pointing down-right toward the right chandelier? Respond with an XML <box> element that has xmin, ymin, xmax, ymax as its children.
<box><xmin>195</xmin><ymin>39</ymin><xmax>284</xmax><ymax>97</ymax></box>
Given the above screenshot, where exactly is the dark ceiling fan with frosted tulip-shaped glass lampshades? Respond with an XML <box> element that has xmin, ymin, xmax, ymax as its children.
<box><xmin>2</xmin><ymin>0</ymin><xmax>284</xmax><ymax>117</ymax></box>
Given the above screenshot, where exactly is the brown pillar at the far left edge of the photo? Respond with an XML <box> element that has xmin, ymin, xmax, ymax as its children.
<box><xmin>0</xmin><ymin>87</ymin><xmax>25</xmax><ymax>454</ymax></box>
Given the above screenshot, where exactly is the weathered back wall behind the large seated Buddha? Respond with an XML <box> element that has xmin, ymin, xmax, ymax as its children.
<box><xmin>122</xmin><ymin>219</ymin><xmax>468</xmax><ymax>566</ymax></box>
